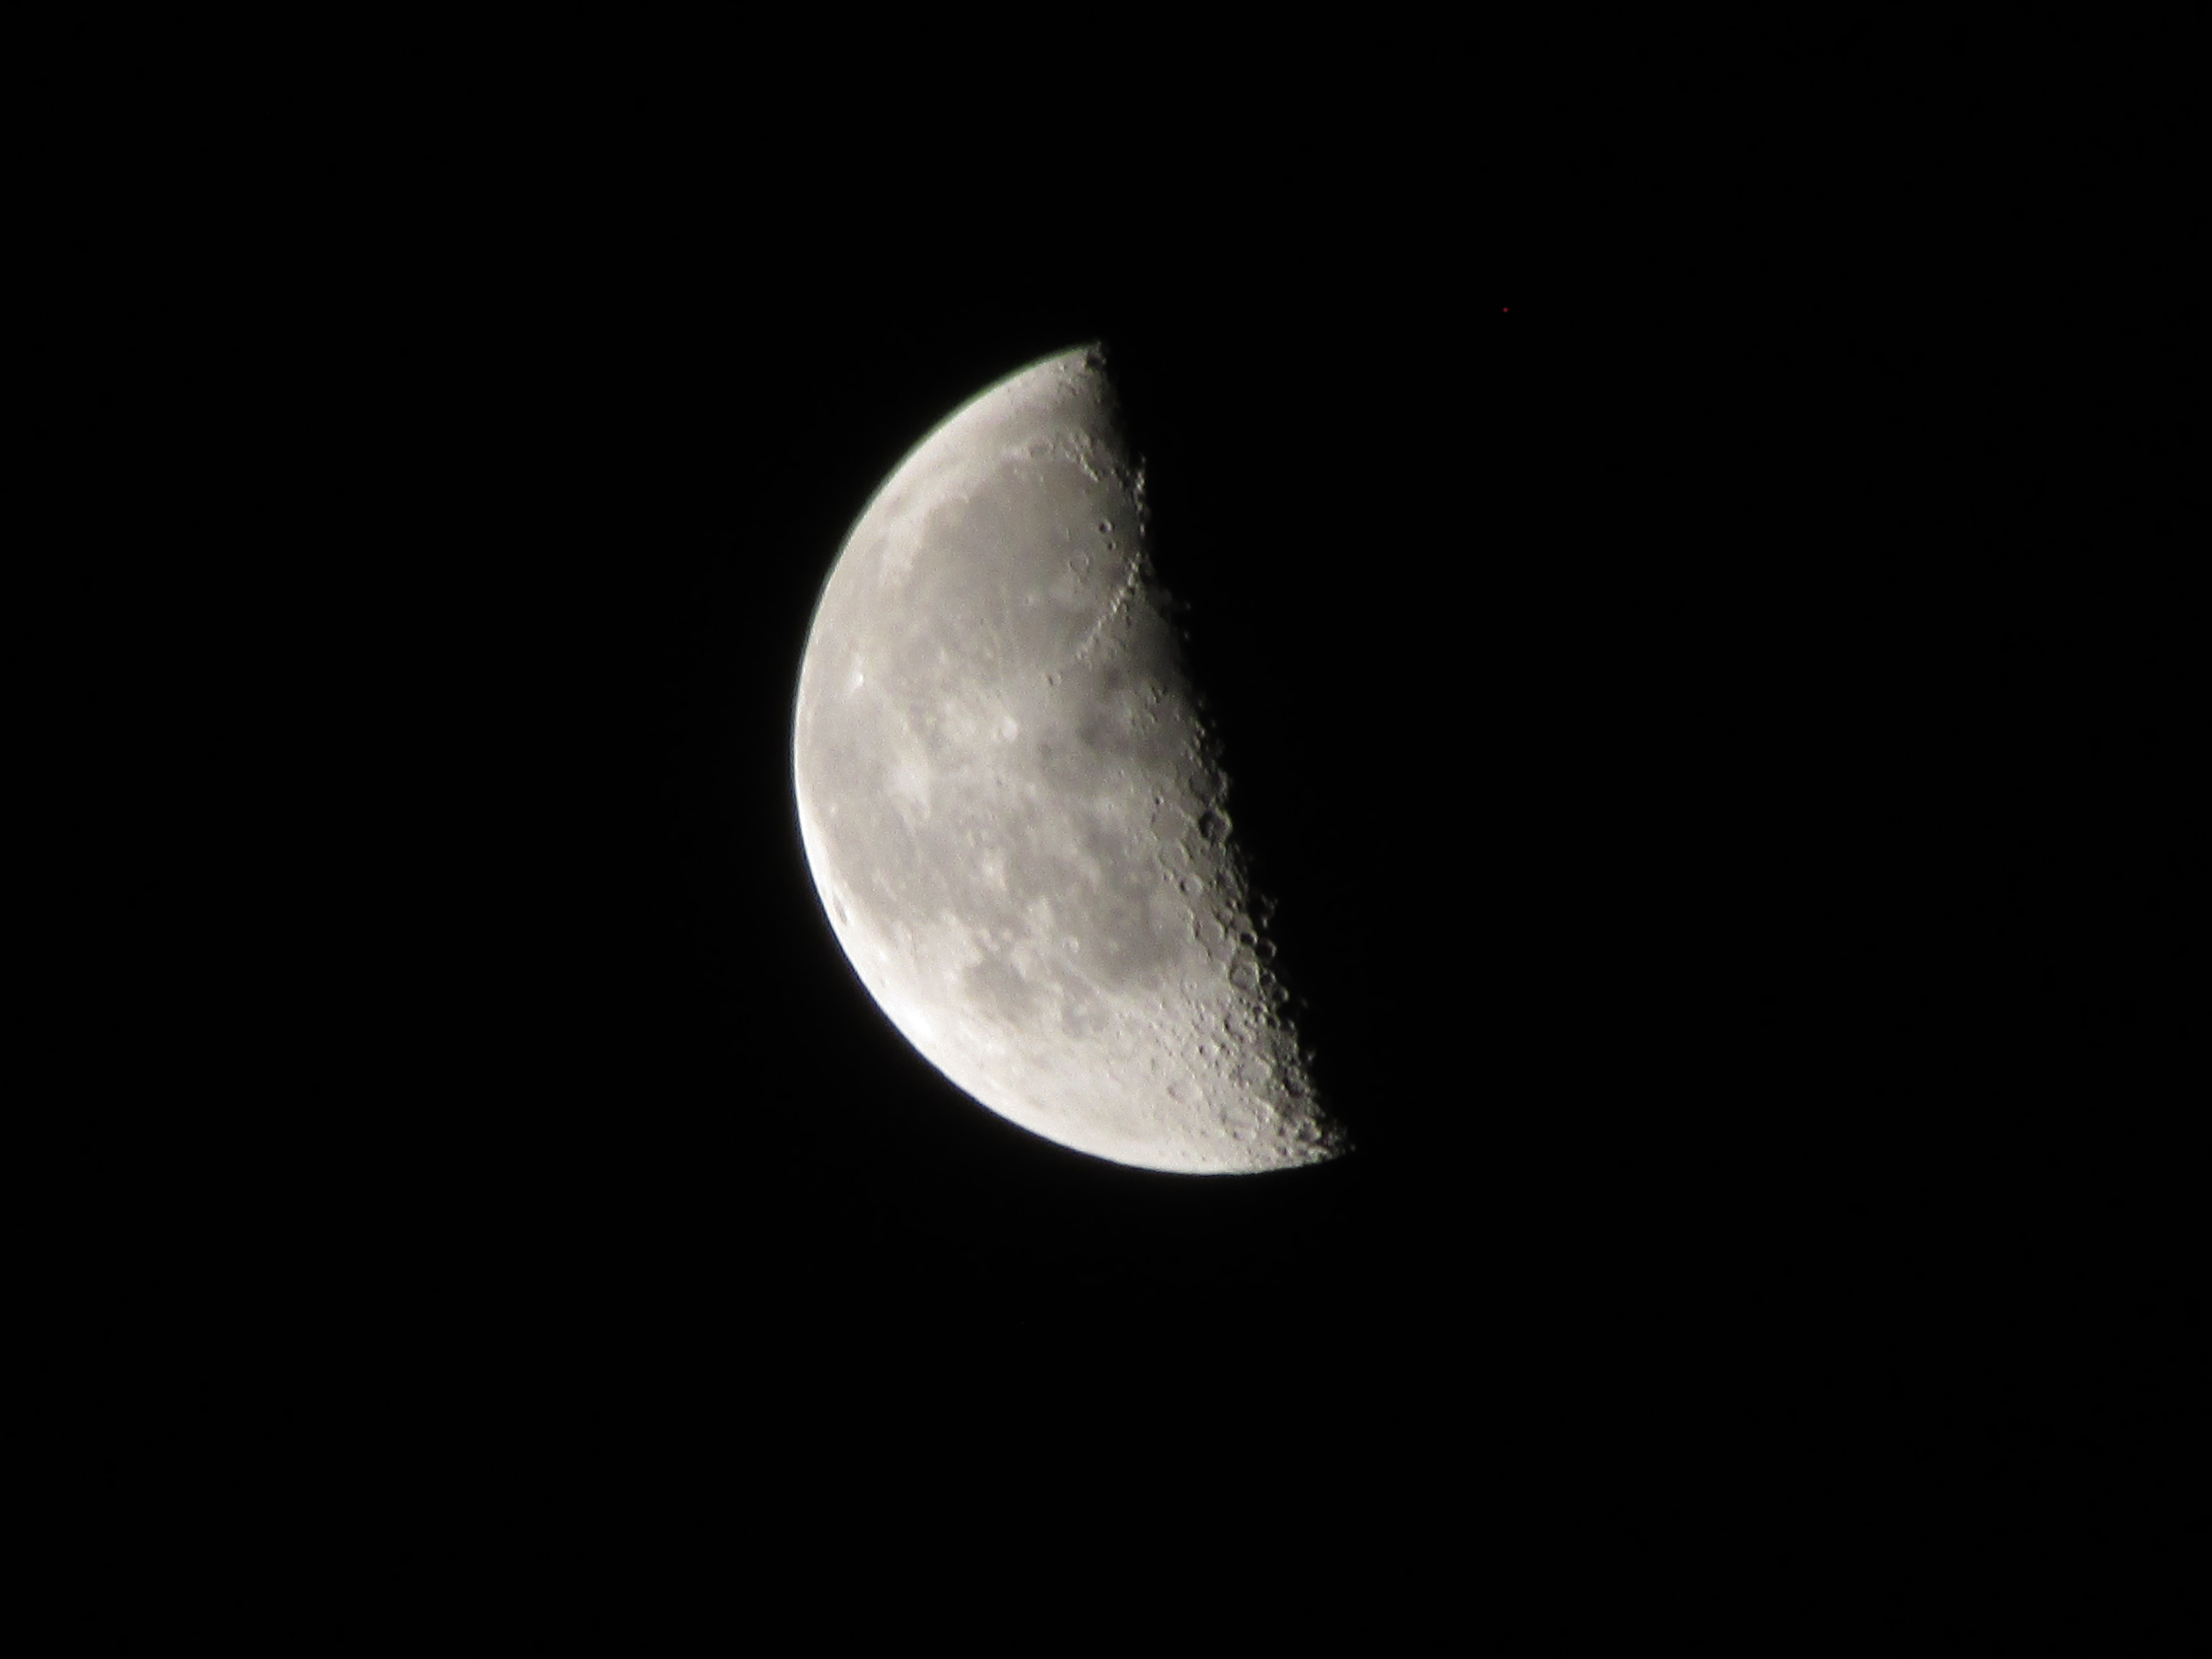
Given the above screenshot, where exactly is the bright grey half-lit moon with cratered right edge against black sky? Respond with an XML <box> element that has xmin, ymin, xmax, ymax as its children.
<box><xmin>792</xmin><ymin>347</ymin><xmax>1349</xmax><ymax>1175</ymax></box>
